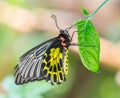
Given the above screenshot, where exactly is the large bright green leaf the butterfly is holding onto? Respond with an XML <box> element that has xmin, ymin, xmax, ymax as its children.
<box><xmin>76</xmin><ymin>20</ymin><xmax>100</xmax><ymax>72</ymax></box>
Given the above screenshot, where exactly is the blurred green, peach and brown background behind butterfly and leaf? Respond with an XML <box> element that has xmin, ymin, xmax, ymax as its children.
<box><xmin>0</xmin><ymin>0</ymin><xmax>120</xmax><ymax>98</ymax></box>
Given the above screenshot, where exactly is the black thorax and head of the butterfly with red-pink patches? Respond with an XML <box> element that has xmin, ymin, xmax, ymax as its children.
<box><xmin>58</xmin><ymin>30</ymin><xmax>71</xmax><ymax>47</ymax></box>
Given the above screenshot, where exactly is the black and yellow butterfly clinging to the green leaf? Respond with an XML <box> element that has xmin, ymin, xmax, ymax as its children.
<box><xmin>14</xmin><ymin>15</ymin><xmax>77</xmax><ymax>85</ymax></box>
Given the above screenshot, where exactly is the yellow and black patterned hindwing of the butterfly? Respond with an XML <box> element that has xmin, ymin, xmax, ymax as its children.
<box><xmin>43</xmin><ymin>44</ymin><xmax>68</xmax><ymax>84</ymax></box>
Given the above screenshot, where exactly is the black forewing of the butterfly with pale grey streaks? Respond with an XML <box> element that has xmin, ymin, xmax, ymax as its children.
<box><xmin>15</xmin><ymin>38</ymin><xmax>57</xmax><ymax>84</ymax></box>
